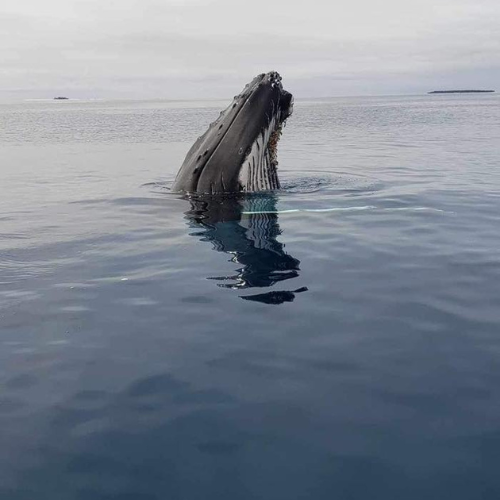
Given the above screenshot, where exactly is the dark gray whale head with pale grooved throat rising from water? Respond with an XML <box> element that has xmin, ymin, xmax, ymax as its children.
<box><xmin>172</xmin><ymin>71</ymin><xmax>293</xmax><ymax>194</ymax></box>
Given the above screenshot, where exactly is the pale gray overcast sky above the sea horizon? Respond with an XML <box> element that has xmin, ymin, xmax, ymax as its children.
<box><xmin>0</xmin><ymin>0</ymin><xmax>500</xmax><ymax>99</ymax></box>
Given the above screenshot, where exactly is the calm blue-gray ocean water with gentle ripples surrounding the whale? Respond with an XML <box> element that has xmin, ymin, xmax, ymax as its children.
<box><xmin>0</xmin><ymin>95</ymin><xmax>500</xmax><ymax>500</ymax></box>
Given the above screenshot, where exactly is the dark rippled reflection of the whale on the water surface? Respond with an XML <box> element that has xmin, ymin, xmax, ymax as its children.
<box><xmin>186</xmin><ymin>193</ymin><xmax>307</xmax><ymax>304</ymax></box>
